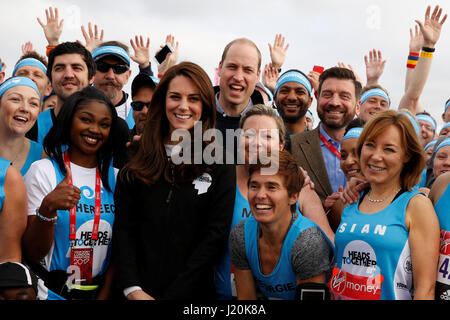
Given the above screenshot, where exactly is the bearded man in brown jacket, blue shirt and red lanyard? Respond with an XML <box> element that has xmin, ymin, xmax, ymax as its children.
<box><xmin>291</xmin><ymin>67</ymin><xmax>361</xmax><ymax>202</ymax></box>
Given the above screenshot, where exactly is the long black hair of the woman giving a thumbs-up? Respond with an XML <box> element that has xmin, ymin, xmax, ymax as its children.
<box><xmin>44</xmin><ymin>86</ymin><xmax>119</xmax><ymax>191</ymax></box>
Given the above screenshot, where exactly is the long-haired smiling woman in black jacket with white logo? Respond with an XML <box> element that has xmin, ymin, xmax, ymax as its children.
<box><xmin>113</xmin><ymin>62</ymin><xmax>236</xmax><ymax>300</ymax></box>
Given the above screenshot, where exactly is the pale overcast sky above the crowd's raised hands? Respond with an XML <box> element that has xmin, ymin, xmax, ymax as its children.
<box><xmin>0</xmin><ymin>0</ymin><xmax>450</xmax><ymax>129</ymax></box>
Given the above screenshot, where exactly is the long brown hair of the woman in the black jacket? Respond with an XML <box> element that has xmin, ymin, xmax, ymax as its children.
<box><xmin>121</xmin><ymin>62</ymin><xmax>216</xmax><ymax>185</ymax></box>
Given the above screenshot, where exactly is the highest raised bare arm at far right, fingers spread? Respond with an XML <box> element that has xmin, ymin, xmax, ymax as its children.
<box><xmin>398</xmin><ymin>6</ymin><xmax>447</xmax><ymax>115</ymax></box>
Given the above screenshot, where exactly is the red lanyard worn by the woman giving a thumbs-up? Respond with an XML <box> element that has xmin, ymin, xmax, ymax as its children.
<box><xmin>64</xmin><ymin>151</ymin><xmax>102</xmax><ymax>240</ymax></box>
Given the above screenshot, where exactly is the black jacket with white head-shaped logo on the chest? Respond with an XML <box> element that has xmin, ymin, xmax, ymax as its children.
<box><xmin>112</xmin><ymin>165</ymin><xmax>236</xmax><ymax>300</ymax></box>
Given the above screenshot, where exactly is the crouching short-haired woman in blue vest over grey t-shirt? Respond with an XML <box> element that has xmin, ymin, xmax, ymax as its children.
<box><xmin>230</xmin><ymin>151</ymin><xmax>333</xmax><ymax>300</ymax></box>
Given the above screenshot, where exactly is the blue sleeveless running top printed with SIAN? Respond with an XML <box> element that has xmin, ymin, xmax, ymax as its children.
<box><xmin>329</xmin><ymin>188</ymin><xmax>419</xmax><ymax>300</ymax></box>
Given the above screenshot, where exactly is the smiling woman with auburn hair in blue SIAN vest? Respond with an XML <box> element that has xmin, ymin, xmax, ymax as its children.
<box><xmin>330</xmin><ymin>110</ymin><xmax>439</xmax><ymax>300</ymax></box>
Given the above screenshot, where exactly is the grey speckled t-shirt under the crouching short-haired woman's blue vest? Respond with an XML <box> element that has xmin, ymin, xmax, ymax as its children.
<box><xmin>229</xmin><ymin>213</ymin><xmax>333</xmax><ymax>280</ymax></box>
